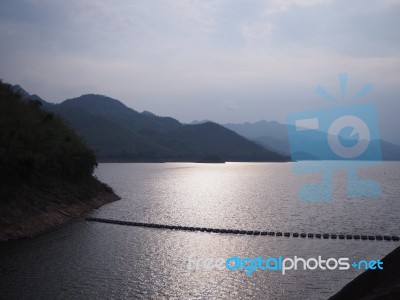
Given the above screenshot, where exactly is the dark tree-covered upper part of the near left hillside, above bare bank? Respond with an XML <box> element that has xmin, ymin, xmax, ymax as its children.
<box><xmin>0</xmin><ymin>82</ymin><xmax>96</xmax><ymax>184</ymax></box>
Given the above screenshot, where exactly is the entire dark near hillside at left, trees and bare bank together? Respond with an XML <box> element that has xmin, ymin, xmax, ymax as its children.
<box><xmin>0</xmin><ymin>81</ymin><xmax>118</xmax><ymax>240</ymax></box>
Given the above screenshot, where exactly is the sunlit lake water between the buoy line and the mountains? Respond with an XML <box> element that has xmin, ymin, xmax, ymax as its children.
<box><xmin>93</xmin><ymin>162</ymin><xmax>400</xmax><ymax>235</ymax></box>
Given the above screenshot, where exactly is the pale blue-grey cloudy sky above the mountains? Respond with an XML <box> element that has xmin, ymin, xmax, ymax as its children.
<box><xmin>0</xmin><ymin>0</ymin><xmax>400</xmax><ymax>144</ymax></box>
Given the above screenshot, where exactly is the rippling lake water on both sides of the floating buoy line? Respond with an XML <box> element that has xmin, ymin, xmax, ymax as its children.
<box><xmin>0</xmin><ymin>162</ymin><xmax>400</xmax><ymax>299</ymax></box>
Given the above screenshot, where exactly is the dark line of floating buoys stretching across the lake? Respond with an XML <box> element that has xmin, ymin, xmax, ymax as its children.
<box><xmin>85</xmin><ymin>217</ymin><xmax>400</xmax><ymax>242</ymax></box>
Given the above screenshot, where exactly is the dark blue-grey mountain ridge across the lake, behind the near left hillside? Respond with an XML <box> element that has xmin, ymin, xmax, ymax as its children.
<box><xmin>14</xmin><ymin>86</ymin><xmax>289</xmax><ymax>162</ymax></box>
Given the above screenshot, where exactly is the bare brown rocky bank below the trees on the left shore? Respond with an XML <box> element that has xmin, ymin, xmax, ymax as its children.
<box><xmin>0</xmin><ymin>180</ymin><xmax>120</xmax><ymax>241</ymax></box>
